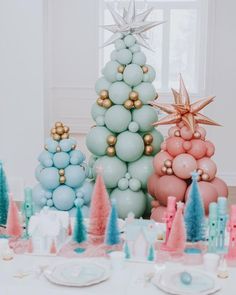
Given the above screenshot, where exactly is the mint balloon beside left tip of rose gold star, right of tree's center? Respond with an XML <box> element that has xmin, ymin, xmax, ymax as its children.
<box><xmin>132</xmin><ymin>105</ymin><xmax>158</xmax><ymax>132</ymax></box>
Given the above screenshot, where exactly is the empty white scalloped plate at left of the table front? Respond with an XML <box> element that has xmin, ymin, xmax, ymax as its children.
<box><xmin>44</xmin><ymin>260</ymin><xmax>110</xmax><ymax>287</ymax></box>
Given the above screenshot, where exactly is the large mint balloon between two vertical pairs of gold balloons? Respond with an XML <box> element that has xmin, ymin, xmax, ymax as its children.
<box><xmin>115</xmin><ymin>131</ymin><xmax>144</xmax><ymax>162</ymax></box>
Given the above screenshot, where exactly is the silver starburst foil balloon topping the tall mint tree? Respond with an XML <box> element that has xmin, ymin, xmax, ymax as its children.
<box><xmin>102</xmin><ymin>0</ymin><xmax>164</xmax><ymax>49</ymax></box>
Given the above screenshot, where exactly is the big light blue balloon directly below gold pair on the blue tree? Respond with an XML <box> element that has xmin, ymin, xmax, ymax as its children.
<box><xmin>52</xmin><ymin>185</ymin><xmax>75</xmax><ymax>211</ymax></box>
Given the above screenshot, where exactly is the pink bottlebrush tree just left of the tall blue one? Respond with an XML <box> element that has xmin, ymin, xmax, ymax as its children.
<box><xmin>166</xmin><ymin>202</ymin><xmax>186</xmax><ymax>252</ymax></box>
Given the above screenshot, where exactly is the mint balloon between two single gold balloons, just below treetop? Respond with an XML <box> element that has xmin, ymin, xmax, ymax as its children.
<box><xmin>123</xmin><ymin>64</ymin><xmax>143</xmax><ymax>86</ymax></box>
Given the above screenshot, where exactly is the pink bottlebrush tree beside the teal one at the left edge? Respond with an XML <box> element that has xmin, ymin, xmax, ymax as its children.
<box><xmin>6</xmin><ymin>195</ymin><xmax>22</xmax><ymax>237</ymax></box>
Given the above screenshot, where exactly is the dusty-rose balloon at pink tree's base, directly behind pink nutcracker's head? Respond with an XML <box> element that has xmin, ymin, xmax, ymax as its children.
<box><xmin>155</xmin><ymin>175</ymin><xmax>187</xmax><ymax>206</ymax></box>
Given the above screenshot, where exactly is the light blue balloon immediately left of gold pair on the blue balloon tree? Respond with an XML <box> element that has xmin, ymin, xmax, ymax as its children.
<box><xmin>39</xmin><ymin>167</ymin><xmax>60</xmax><ymax>190</ymax></box>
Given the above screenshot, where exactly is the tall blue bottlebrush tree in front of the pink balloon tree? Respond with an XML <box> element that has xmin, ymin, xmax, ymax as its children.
<box><xmin>184</xmin><ymin>172</ymin><xmax>205</xmax><ymax>242</ymax></box>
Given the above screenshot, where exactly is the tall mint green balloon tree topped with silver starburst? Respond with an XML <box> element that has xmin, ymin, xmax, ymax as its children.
<box><xmin>86</xmin><ymin>1</ymin><xmax>163</xmax><ymax>218</ymax></box>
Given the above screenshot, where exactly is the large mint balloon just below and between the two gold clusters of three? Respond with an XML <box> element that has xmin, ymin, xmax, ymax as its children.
<box><xmin>105</xmin><ymin>105</ymin><xmax>131</xmax><ymax>133</ymax></box>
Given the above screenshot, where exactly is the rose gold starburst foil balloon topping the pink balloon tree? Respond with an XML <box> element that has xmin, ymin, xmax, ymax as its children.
<box><xmin>150</xmin><ymin>75</ymin><xmax>220</xmax><ymax>133</ymax></box>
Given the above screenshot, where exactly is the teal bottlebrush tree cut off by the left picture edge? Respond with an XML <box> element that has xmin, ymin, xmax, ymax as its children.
<box><xmin>0</xmin><ymin>161</ymin><xmax>9</xmax><ymax>225</ymax></box>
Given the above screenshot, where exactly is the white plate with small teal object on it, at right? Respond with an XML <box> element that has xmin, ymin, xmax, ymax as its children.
<box><xmin>152</xmin><ymin>268</ymin><xmax>220</xmax><ymax>295</ymax></box>
